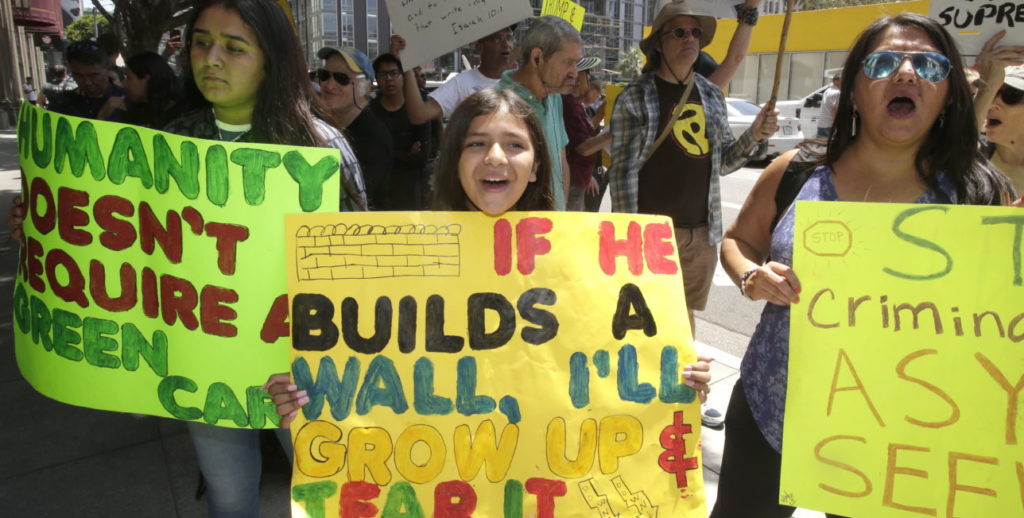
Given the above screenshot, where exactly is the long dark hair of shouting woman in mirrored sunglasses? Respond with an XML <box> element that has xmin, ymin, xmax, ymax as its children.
<box><xmin>824</xmin><ymin>12</ymin><xmax>1012</xmax><ymax>205</ymax></box>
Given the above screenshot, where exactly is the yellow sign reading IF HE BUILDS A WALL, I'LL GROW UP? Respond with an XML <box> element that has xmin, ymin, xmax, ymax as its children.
<box><xmin>287</xmin><ymin>212</ymin><xmax>706</xmax><ymax>518</ymax></box>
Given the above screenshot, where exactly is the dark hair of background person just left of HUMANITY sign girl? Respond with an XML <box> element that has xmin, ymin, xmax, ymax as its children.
<box><xmin>125</xmin><ymin>50</ymin><xmax>181</xmax><ymax>129</ymax></box>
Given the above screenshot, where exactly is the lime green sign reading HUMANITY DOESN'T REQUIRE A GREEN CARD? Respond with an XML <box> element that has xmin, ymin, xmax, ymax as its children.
<box><xmin>13</xmin><ymin>103</ymin><xmax>340</xmax><ymax>428</ymax></box>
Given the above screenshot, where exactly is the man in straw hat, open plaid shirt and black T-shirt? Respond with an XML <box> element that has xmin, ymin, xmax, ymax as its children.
<box><xmin>609</xmin><ymin>0</ymin><xmax>777</xmax><ymax>426</ymax></box>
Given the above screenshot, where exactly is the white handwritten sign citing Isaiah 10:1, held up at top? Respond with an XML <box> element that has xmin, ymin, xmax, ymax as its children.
<box><xmin>385</xmin><ymin>0</ymin><xmax>534</xmax><ymax>67</ymax></box>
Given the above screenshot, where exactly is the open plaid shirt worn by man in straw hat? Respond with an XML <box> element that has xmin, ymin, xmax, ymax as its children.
<box><xmin>608</xmin><ymin>73</ymin><xmax>767</xmax><ymax>244</ymax></box>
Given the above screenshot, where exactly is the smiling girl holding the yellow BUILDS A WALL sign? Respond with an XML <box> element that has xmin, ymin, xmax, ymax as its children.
<box><xmin>263</xmin><ymin>88</ymin><xmax>712</xmax><ymax>428</ymax></box>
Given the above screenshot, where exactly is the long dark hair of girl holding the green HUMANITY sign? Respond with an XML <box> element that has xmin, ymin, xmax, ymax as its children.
<box><xmin>182</xmin><ymin>0</ymin><xmax>326</xmax><ymax>146</ymax></box>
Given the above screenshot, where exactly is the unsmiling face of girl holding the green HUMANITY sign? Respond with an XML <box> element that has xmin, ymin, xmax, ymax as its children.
<box><xmin>190</xmin><ymin>5</ymin><xmax>265</xmax><ymax>120</ymax></box>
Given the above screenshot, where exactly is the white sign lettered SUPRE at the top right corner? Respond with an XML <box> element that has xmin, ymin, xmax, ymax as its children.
<box><xmin>928</xmin><ymin>0</ymin><xmax>1024</xmax><ymax>55</ymax></box>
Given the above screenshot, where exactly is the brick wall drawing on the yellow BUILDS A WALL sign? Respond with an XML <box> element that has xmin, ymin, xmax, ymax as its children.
<box><xmin>296</xmin><ymin>224</ymin><xmax>462</xmax><ymax>280</ymax></box>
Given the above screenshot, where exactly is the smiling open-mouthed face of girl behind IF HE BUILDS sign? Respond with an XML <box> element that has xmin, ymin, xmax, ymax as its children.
<box><xmin>459</xmin><ymin>110</ymin><xmax>537</xmax><ymax>216</ymax></box>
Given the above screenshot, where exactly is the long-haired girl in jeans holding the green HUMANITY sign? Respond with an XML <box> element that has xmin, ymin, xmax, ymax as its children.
<box><xmin>157</xmin><ymin>0</ymin><xmax>366</xmax><ymax>517</ymax></box>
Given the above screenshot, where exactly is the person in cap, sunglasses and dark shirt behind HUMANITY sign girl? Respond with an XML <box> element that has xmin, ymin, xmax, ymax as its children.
<box><xmin>316</xmin><ymin>47</ymin><xmax>394</xmax><ymax>210</ymax></box>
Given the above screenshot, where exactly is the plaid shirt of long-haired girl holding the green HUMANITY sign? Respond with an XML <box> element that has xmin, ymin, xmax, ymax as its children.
<box><xmin>164</xmin><ymin>109</ymin><xmax>367</xmax><ymax>212</ymax></box>
